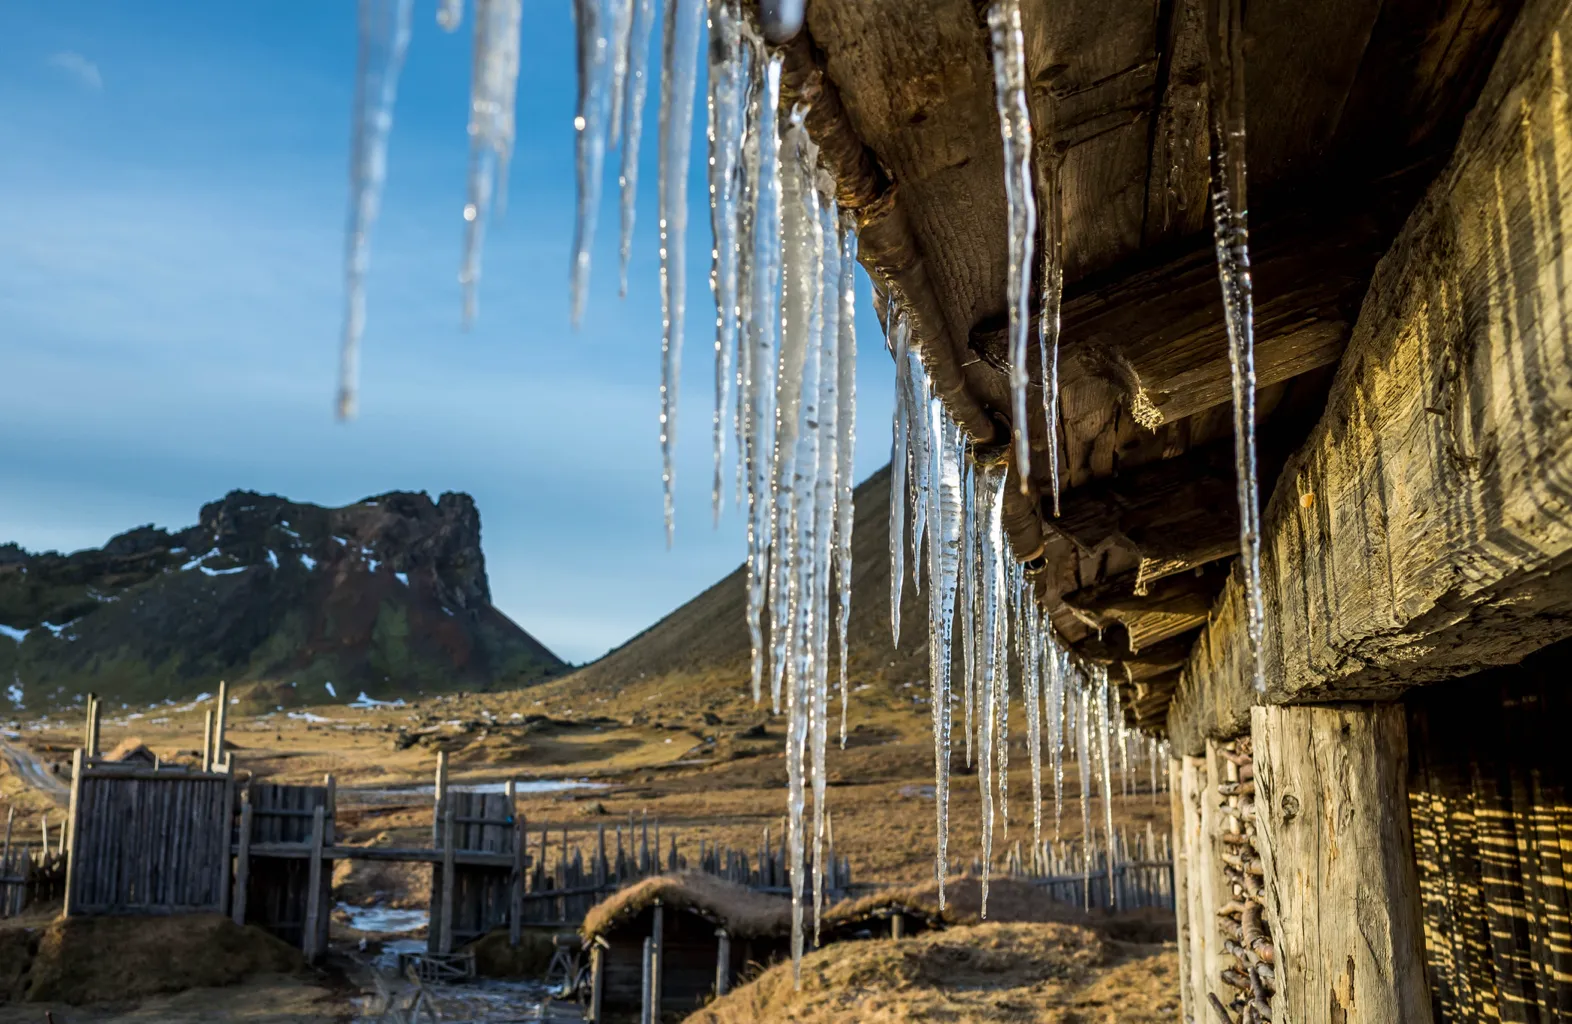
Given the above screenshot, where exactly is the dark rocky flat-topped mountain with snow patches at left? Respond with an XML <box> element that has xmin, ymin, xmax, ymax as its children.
<box><xmin>0</xmin><ymin>491</ymin><xmax>566</xmax><ymax>711</ymax></box>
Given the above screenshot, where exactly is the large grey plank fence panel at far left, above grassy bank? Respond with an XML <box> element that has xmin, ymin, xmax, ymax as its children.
<box><xmin>64</xmin><ymin>750</ymin><xmax>234</xmax><ymax>915</ymax></box>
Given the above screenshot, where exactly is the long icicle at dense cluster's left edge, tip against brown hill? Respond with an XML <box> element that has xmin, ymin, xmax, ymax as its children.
<box><xmin>741</xmin><ymin>47</ymin><xmax>781</xmax><ymax>703</ymax></box>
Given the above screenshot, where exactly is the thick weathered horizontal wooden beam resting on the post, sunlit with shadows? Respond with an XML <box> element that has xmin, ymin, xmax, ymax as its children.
<box><xmin>1168</xmin><ymin>0</ymin><xmax>1572</xmax><ymax>750</ymax></box>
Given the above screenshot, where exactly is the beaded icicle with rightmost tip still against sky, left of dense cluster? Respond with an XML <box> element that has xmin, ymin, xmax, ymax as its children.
<box><xmin>709</xmin><ymin>0</ymin><xmax>751</xmax><ymax>525</ymax></box>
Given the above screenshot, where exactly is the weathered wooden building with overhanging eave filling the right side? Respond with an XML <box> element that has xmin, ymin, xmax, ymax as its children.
<box><xmin>767</xmin><ymin>0</ymin><xmax>1572</xmax><ymax>1024</ymax></box>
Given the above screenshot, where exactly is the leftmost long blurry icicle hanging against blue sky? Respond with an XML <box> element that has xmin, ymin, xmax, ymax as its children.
<box><xmin>338</xmin><ymin>0</ymin><xmax>413</xmax><ymax>420</ymax></box>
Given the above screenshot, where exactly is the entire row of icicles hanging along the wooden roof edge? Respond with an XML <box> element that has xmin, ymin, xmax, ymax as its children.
<box><xmin>338</xmin><ymin>0</ymin><xmax>1261</xmax><ymax>987</ymax></box>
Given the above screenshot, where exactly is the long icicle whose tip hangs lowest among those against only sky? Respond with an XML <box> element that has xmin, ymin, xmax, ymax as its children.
<box><xmin>657</xmin><ymin>0</ymin><xmax>703</xmax><ymax>547</ymax></box>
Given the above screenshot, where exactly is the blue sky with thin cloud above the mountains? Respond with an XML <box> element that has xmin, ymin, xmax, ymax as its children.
<box><xmin>0</xmin><ymin>0</ymin><xmax>893</xmax><ymax>662</ymax></box>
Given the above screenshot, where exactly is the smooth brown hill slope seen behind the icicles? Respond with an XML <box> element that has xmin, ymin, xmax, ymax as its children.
<box><xmin>542</xmin><ymin>467</ymin><xmax>927</xmax><ymax>722</ymax></box>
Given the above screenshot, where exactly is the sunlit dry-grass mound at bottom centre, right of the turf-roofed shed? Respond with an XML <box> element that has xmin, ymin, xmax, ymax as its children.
<box><xmin>689</xmin><ymin>922</ymin><xmax>1179</xmax><ymax>1024</ymax></box>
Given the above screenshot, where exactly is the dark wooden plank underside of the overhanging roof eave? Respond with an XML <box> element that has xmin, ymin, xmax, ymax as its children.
<box><xmin>783</xmin><ymin>0</ymin><xmax>1520</xmax><ymax>731</ymax></box>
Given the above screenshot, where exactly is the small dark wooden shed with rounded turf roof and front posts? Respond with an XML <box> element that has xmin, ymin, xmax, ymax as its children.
<box><xmin>583</xmin><ymin>873</ymin><xmax>791</xmax><ymax>1022</ymax></box>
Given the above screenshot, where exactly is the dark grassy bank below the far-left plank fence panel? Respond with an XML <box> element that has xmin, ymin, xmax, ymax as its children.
<box><xmin>20</xmin><ymin>914</ymin><xmax>303</xmax><ymax>1005</ymax></box>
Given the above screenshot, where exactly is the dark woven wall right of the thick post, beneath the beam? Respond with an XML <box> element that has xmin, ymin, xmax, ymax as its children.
<box><xmin>1407</xmin><ymin>642</ymin><xmax>1572</xmax><ymax>1024</ymax></box>
